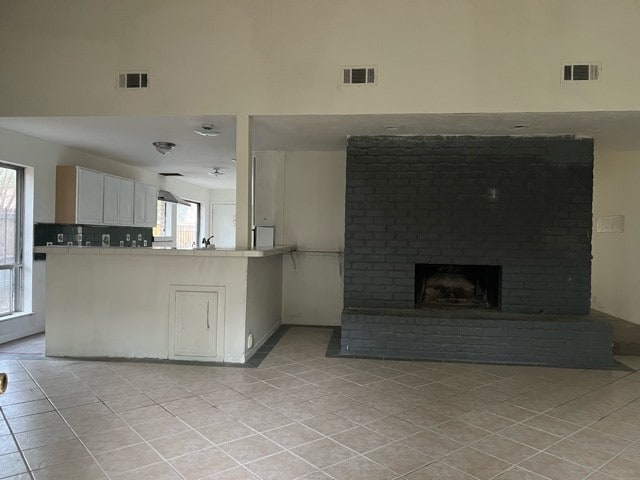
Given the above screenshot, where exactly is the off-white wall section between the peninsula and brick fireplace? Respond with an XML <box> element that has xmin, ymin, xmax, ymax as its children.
<box><xmin>256</xmin><ymin>151</ymin><xmax>346</xmax><ymax>325</ymax></box>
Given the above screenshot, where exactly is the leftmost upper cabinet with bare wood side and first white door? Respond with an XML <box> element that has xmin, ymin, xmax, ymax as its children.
<box><xmin>56</xmin><ymin>166</ymin><xmax>104</xmax><ymax>225</ymax></box>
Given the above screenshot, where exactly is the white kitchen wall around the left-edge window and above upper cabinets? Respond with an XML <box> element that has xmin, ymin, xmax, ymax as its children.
<box><xmin>0</xmin><ymin>129</ymin><xmax>215</xmax><ymax>343</ymax></box>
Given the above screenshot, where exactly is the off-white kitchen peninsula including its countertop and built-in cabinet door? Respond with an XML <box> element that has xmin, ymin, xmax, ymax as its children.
<box><xmin>35</xmin><ymin>246</ymin><xmax>292</xmax><ymax>363</ymax></box>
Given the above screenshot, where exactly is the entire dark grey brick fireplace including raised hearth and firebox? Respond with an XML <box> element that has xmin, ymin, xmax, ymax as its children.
<box><xmin>342</xmin><ymin>136</ymin><xmax>611</xmax><ymax>366</ymax></box>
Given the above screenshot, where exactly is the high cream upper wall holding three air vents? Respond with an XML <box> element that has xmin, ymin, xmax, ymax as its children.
<box><xmin>0</xmin><ymin>0</ymin><xmax>640</xmax><ymax>116</ymax></box>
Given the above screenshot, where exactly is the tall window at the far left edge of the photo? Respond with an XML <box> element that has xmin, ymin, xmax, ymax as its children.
<box><xmin>0</xmin><ymin>163</ymin><xmax>24</xmax><ymax>316</ymax></box>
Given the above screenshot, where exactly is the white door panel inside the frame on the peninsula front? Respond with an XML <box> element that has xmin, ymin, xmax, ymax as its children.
<box><xmin>174</xmin><ymin>291</ymin><xmax>218</xmax><ymax>357</ymax></box>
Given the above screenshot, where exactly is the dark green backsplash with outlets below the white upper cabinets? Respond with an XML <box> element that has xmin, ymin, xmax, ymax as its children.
<box><xmin>33</xmin><ymin>223</ymin><xmax>153</xmax><ymax>247</ymax></box>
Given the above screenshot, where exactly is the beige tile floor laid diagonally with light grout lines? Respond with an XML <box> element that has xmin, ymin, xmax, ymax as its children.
<box><xmin>0</xmin><ymin>327</ymin><xmax>640</xmax><ymax>480</ymax></box>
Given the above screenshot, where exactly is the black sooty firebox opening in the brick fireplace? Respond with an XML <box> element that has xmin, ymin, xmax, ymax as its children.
<box><xmin>415</xmin><ymin>263</ymin><xmax>500</xmax><ymax>309</ymax></box>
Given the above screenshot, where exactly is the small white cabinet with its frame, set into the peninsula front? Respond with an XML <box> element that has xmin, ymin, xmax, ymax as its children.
<box><xmin>169</xmin><ymin>285</ymin><xmax>224</xmax><ymax>361</ymax></box>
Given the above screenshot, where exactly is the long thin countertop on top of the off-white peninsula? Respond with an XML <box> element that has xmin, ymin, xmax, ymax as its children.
<box><xmin>33</xmin><ymin>245</ymin><xmax>296</xmax><ymax>257</ymax></box>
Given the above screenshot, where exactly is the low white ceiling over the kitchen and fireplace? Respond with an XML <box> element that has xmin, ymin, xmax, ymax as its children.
<box><xmin>0</xmin><ymin>112</ymin><xmax>640</xmax><ymax>188</ymax></box>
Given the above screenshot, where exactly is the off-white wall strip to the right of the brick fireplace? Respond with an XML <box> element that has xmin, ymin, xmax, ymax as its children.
<box><xmin>591</xmin><ymin>146</ymin><xmax>640</xmax><ymax>324</ymax></box>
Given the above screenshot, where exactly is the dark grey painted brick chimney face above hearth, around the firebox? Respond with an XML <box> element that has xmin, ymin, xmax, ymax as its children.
<box><xmin>344</xmin><ymin>136</ymin><xmax>593</xmax><ymax>314</ymax></box>
